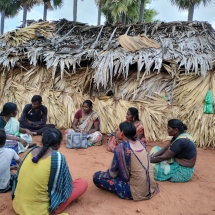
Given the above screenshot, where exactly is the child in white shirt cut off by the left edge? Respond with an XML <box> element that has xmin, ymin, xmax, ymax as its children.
<box><xmin>0</xmin><ymin>129</ymin><xmax>21</xmax><ymax>193</ymax></box>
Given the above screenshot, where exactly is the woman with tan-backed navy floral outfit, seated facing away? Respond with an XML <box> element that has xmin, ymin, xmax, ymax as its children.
<box><xmin>93</xmin><ymin>122</ymin><xmax>159</xmax><ymax>201</ymax></box>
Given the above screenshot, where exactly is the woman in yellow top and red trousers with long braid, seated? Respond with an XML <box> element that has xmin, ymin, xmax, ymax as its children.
<box><xmin>13</xmin><ymin>128</ymin><xmax>88</xmax><ymax>215</ymax></box>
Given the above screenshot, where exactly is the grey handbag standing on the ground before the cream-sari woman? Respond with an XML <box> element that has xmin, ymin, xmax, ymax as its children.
<box><xmin>66</xmin><ymin>132</ymin><xmax>88</xmax><ymax>149</ymax></box>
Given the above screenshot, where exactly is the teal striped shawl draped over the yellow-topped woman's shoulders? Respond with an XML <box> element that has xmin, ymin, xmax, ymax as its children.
<box><xmin>12</xmin><ymin>147</ymin><xmax>73</xmax><ymax>214</ymax></box>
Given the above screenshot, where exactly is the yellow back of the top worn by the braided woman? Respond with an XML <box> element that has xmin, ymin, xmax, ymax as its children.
<box><xmin>13</xmin><ymin>153</ymin><xmax>51</xmax><ymax>215</ymax></box>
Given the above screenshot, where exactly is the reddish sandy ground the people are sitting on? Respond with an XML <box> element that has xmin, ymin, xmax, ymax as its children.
<box><xmin>0</xmin><ymin>136</ymin><xmax>215</xmax><ymax>215</ymax></box>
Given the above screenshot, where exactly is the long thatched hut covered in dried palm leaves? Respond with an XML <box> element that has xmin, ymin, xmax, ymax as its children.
<box><xmin>0</xmin><ymin>20</ymin><xmax>215</xmax><ymax>148</ymax></box>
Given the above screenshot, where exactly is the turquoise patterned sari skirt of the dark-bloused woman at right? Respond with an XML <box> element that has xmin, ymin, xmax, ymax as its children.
<box><xmin>150</xmin><ymin>146</ymin><xmax>194</xmax><ymax>182</ymax></box>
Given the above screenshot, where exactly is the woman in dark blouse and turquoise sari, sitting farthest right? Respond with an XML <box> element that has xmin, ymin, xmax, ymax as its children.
<box><xmin>150</xmin><ymin>119</ymin><xmax>197</xmax><ymax>182</ymax></box>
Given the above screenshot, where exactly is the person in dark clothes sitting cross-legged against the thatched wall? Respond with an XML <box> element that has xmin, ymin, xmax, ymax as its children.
<box><xmin>19</xmin><ymin>95</ymin><xmax>55</xmax><ymax>135</ymax></box>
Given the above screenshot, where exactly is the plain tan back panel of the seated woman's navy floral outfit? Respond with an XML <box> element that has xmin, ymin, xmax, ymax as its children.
<box><xmin>130</xmin><ymin>145</ymin><xmax>157</xmax><ymax>201</ymax></box>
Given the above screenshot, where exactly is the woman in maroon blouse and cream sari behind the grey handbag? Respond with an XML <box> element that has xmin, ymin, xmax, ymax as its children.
<box><xmin>65</xmin><ymin>100</ymin><xmax>102</xmax><ymax>146</ymax></box>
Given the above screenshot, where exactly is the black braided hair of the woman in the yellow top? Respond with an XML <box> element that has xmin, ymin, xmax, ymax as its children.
<box><xmin>32</xmin><ymin>128</ymin><xmax>62</xmax><ymax>163</ymax></box>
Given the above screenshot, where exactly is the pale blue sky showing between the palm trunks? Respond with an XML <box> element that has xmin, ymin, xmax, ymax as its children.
<box><xmin>5</xmin><ymin>0</ymin><xmax>215</xmax><ymax>32</ymax></box>
